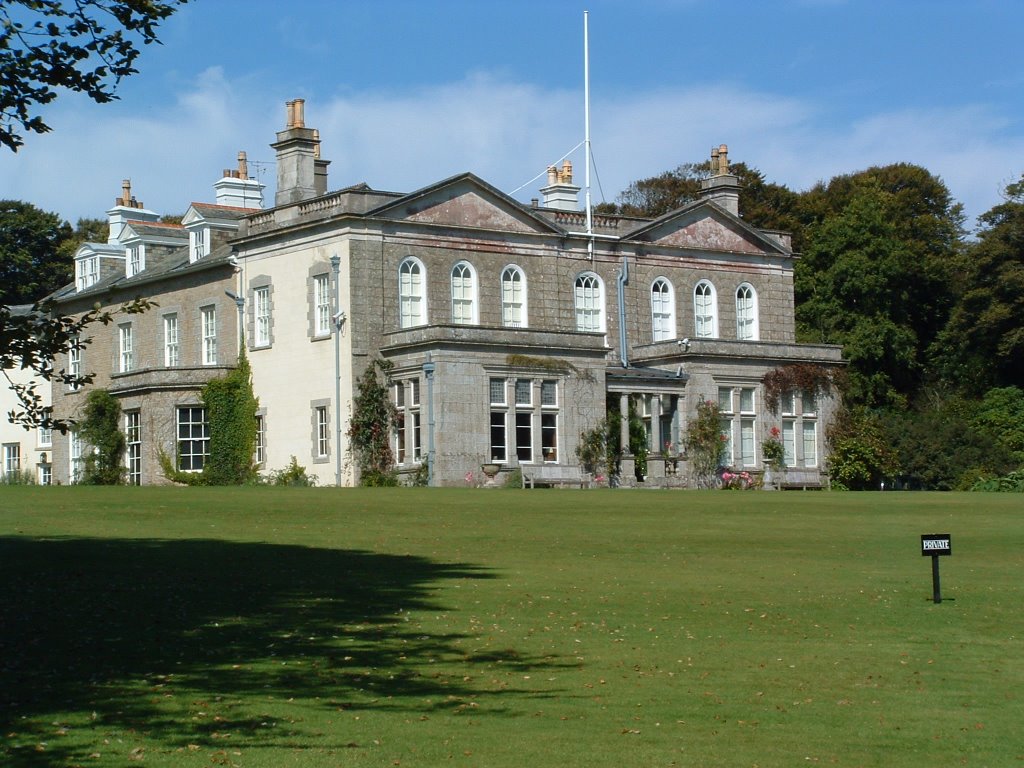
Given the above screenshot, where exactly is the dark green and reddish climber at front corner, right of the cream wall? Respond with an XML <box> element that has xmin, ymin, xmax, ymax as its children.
<box><xmin>348</xmin><ymin>359</ymin><xmax>398</xmax><ymax>485</ymax></box>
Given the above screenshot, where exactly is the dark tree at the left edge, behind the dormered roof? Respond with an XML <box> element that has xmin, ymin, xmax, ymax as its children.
<box><xmin>0</xmin><ymin>200</ymin><xmax>72</xmax><ymax>304</ymax></box>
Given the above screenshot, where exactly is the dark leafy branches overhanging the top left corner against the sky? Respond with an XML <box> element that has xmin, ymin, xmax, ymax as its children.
<box><xmin>0</xmin><ymin>0</ymin><xmax>187</xmax><ymax>151</ymax></box>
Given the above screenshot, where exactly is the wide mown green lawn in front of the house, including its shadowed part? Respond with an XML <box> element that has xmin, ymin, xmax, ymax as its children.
<box><xmin>0</xmin><ymin>487</ymin><xmax>1024</xmax><ymax>768</ymax></box>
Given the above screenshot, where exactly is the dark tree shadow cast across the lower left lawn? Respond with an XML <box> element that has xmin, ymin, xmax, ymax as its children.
<box><xmin>0</xmin><ymin>538</ymin><xmax>559</xmax><ymax>765</ymax></box>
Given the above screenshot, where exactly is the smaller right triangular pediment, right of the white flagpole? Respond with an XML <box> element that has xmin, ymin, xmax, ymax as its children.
<box><xmin>630</xmin><ymin>202</ymin><xmax>788</xmax><ymax>255</ymax></box>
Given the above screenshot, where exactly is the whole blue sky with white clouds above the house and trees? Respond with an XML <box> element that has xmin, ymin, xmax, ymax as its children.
<box><xmin>0</xmin><ymin>0</ymin><xmax>1024</xmax><ymax>224</ymax></box>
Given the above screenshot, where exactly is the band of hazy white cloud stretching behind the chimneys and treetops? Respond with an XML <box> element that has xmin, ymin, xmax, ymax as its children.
<box><xmin>0</xmin><ymin>68</ymin><xmax>1024</xmax><ymax>228</ymax></box>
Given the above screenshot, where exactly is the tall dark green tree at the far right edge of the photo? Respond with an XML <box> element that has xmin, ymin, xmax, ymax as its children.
<box><xmin>935</xmin><ymin>175</ymin><xmax>1024</xmax><ymax>394</ymax></box>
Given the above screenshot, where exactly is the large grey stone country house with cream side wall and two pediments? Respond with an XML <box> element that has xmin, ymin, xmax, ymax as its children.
<box><xmin>46</xmin><ymin>101</ymin><xmax>842</xmax><ymax>485</ymax></box>
